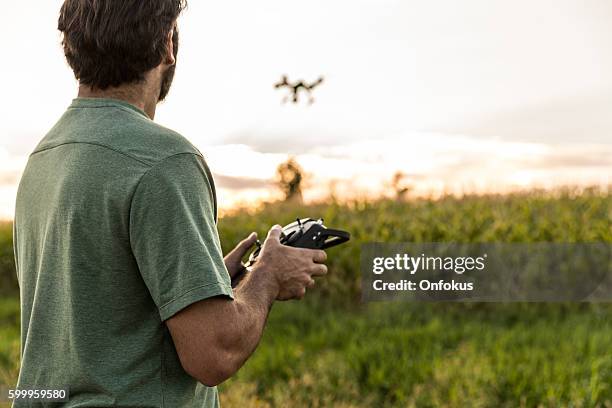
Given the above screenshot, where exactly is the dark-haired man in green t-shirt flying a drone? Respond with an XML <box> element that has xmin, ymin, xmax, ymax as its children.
<box><xmin>14</xmin><ymin>0</ymin><xmax>327</xmax><ymax>407</ymax></box>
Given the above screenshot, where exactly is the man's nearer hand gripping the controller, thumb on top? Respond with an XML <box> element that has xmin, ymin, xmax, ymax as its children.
<box><xmin>253</xmin><ymin>225</ymin><xmax>327</xmax><ymax>300</ymax></box>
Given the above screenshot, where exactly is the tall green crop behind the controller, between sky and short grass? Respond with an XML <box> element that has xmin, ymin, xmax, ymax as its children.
<box><xmin>219</xmin><ymin>189</ymin><xmax>612</xmax><ymax>304</ymax></box>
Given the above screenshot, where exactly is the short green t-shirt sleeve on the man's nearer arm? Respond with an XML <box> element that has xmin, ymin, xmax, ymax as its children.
<box><xmin>130</xmin><ymin>154</ymin><xmax>233</xmax><ymax>320</ymax></box>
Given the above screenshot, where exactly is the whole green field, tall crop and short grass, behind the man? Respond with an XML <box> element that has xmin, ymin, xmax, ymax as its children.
<box><xmin>0</xmin><ymin>190</ymin><xmax>612</xmax><ymax>407</ymax></box>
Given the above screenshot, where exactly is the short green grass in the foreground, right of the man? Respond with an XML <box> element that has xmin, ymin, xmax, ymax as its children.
<box><xmin>221</xmin><ymin>301</ymin><xmax>612</xmax><ymax>407</ymax></box>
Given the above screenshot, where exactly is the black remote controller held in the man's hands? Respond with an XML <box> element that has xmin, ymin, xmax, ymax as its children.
<box><xmin>247</xmin><ymin>218</ymin><xmax>351</xmax><ymax>266</ymax></box>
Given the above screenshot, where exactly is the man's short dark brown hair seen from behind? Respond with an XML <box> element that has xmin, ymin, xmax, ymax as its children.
<box><xmin>58</xmin><ymin>0</ymin><xmax>186</xmax><ymax>90</ymax></box>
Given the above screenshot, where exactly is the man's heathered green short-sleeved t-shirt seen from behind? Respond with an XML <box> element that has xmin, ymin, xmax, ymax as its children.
<box><xmin>14</xmin><ymin>98</ymin><xmax>233</xmax><ymax>408</ymax></box>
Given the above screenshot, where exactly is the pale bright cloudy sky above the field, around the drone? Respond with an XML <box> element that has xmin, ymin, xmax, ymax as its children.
<box><xmin>0</xmin><ymin>0</ymin><xmax>612</xmax><ymax>218</ymax></box>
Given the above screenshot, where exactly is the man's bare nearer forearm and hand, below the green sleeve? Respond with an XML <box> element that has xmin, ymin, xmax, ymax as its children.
<box><xmin>166</xmin><ymin>226</ymin><xmax>327</xmax><ymax>386</ymax></box>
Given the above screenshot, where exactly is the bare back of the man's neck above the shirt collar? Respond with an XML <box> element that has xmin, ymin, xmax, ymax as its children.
<box><xmin>78</xmin><ymin>83</ymin><xmax>159</xmax><ymax>120</ymax></box>
